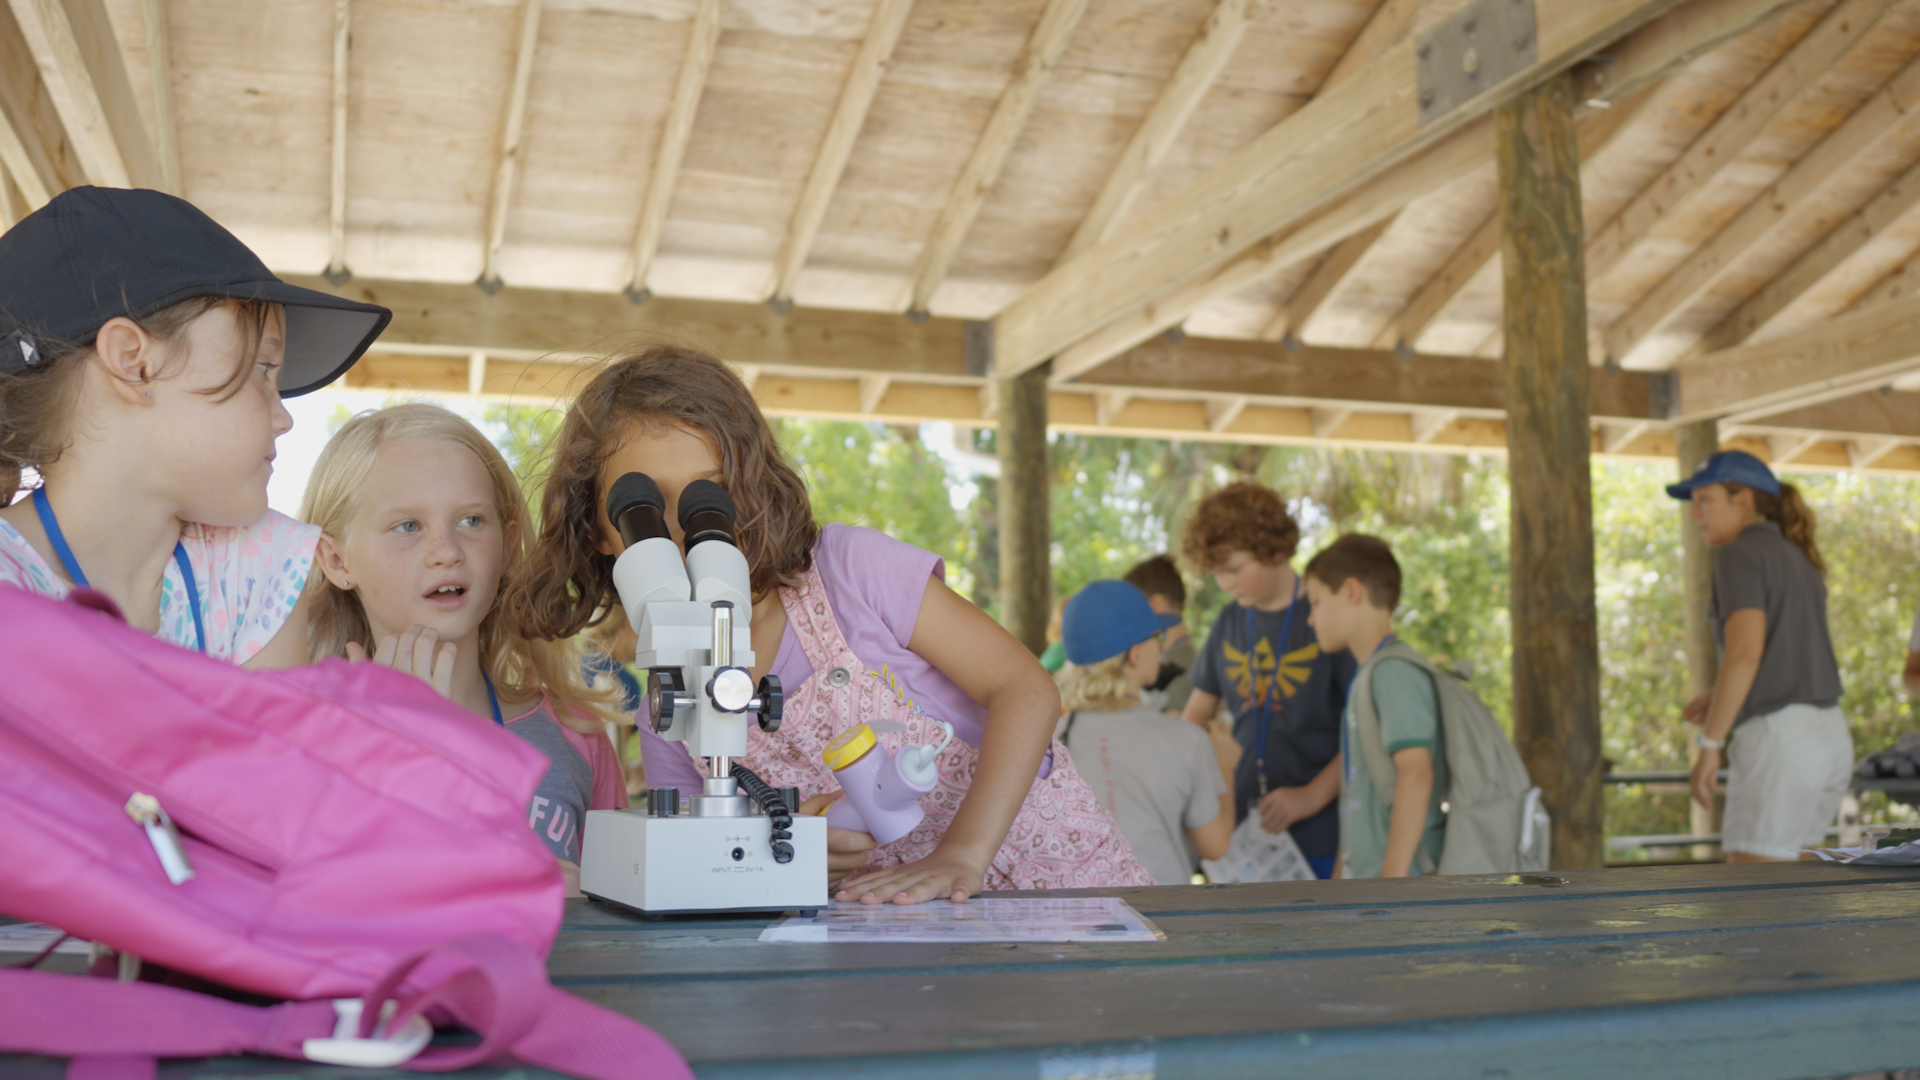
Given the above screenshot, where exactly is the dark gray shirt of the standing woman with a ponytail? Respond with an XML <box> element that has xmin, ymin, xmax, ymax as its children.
<box><xmin>1707</xmin><ymin>521</ymin><xmax>1839</xmax><ymax>724</ymax></box>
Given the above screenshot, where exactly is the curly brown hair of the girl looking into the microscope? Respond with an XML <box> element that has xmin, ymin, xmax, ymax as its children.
<box><xmin>501</xmin><ymin>346</ymin><xmax>820</xmax><ymax>638</ymax></box>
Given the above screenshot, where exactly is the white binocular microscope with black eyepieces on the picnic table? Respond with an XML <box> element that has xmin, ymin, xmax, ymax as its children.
<box><xmin>580</xmin><ymin>473</ymin><xmax>828</xmax><ymax>915</ymax></box>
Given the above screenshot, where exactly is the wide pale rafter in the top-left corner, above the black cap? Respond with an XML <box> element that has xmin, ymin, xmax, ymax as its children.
<box><xmin>12</xmin><ymin>0</ymin><xmax>165</xmax><ymax>188</ymax></box>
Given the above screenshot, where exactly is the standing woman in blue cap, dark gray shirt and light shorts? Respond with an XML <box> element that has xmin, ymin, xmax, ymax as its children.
<box><xmin>1667</xmin><ymin>450</ymin><xmax>1853</xmax><ymax>863</ymax></box>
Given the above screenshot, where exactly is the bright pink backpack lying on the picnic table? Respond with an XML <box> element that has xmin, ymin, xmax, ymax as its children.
<box><xmin>0</xmin><ymin>586</ymin><xmax>689</xmax><ymax>1076</ymax></box>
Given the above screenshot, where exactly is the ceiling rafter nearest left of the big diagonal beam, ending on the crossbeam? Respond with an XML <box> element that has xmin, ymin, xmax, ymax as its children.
<box><xmin>904</xmin><ymin>0</ymin><xmax>1087</xmax><ymax>315</ymax></box>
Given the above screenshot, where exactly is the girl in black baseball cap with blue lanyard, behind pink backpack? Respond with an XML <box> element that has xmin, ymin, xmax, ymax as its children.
<box><xmin>0</xmin><ymin>188</ymin><xmax>390</xmax><ymax>667</ymax></box>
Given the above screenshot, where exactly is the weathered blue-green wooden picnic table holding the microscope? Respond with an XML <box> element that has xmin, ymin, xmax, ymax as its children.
<box><xmin>11</xmin><ymin>863</ymin><xmax>1920</xmax><ymax>1080</ymax></box>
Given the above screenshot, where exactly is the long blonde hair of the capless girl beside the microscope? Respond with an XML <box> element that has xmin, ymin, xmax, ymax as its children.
<box><xmin>300</xmin><ymin>402</ymin><xmax>618</xmax><ymax>734</ymax></box>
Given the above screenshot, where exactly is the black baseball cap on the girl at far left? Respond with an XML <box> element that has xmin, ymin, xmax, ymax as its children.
<box><xmin>0</xmin><ymin>186</ymin><xmax>394</xmax><ymax>398</ymax></box>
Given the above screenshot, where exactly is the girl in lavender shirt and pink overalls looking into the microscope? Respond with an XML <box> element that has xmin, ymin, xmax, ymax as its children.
<box><xmin>507</xmin><ymin>348</ymin><xmax>1152</xmax><ymax>903</ymax></box>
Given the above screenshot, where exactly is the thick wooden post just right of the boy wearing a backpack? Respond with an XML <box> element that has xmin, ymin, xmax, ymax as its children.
<box><xmin>1494</xmin><ymin>75</ymin><xmax>1605</xmax><ymax>869</ymax></box>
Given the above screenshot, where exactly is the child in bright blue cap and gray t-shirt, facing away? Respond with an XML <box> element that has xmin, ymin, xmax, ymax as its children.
<box><xmin>1058</xmin><ymin>580</ymin><xmax>1240</xmax><ymax>886</ymax></box>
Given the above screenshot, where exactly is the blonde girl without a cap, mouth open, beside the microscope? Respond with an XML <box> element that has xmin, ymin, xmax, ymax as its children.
<box><xmin>300</xmin><ymin>404</ymin><xmax>626</xmax><ymax>884</ymax></box>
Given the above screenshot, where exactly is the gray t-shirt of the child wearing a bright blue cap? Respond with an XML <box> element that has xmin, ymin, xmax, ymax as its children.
<box><xmin>1066</xmin><ymin>707</ymin><xmax>1227</xmax><ymax>886</ymax></box>
